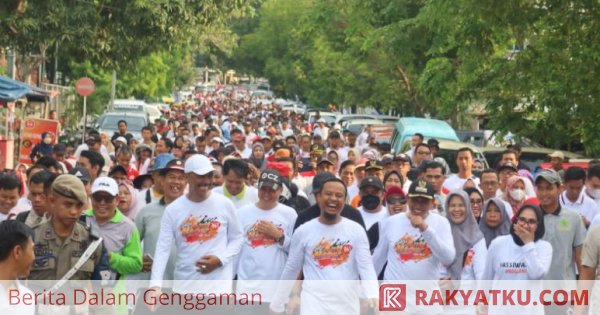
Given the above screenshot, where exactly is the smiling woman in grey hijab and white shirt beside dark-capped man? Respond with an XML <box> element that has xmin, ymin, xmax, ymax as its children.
<box><xmin>442</xmin><ymin>190</ymin><xmax>487</xmax><ymax>314</ymax></box>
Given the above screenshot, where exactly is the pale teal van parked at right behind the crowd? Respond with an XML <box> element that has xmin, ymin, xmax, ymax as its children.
<box><xmin>391</xmin><ymin>117</ymin><xmax>459</xmax><ymax>153</ymax></box>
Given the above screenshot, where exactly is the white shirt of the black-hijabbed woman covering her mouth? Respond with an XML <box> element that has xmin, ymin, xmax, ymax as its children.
<box><xmin>483</xmin><ymin>234</ymin><xmax>552</xmax><ymax>315</ymax></box>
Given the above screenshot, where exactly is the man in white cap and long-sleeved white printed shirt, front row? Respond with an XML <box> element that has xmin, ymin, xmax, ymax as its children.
<box><xmin>149</xmin><ymin>154</ymin><xmax>243</xmax><ymax>304</ymax></box>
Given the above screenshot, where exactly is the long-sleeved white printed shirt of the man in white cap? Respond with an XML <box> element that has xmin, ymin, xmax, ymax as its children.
<box><xmin>150</xmin><ymin>193</ymin><xmax>243</xmax><ymax>293</ymax></box>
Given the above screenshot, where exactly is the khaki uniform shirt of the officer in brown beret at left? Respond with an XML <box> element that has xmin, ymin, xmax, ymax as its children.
<box><xmin>29</xmin><ymin>221</ymin><xmax>108</xmax><ymax>280</ymax></box>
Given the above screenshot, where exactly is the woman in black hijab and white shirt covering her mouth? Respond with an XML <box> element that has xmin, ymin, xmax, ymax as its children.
<box><xmin>483</xmin><ymin>204</ymin><xmax>552</xmax><ymax>315</ymax></box>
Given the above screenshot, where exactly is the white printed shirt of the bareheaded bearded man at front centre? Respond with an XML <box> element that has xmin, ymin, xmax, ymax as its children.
<box><xmin>271</xmin><ymin>218</ymin><xmax>378</xmax><ymax>314</ymax></box>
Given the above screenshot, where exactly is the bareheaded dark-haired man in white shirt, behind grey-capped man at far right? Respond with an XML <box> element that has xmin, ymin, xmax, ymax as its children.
<box><xmin>558</xmin><ymin>166</ymin><xmax>600</xmax><ymax>228</ymax></box>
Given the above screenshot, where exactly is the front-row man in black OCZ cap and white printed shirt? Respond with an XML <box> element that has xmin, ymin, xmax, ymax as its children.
<box><xmin>237</xmin><ymin>169</ymin><xmax>298</xmax><ymax>314</ymax></box>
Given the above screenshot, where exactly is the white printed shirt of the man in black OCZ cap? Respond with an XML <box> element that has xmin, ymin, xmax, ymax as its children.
<box><xmin>237</xmin><ymin>204</ymin><xmax>298</xmax><ymax>302</ymax></box>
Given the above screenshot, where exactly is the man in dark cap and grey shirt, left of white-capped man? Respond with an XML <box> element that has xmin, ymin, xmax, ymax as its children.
<box><xmin>135</xmin><ymin>159</ymin><xmax>186</xmax><ymax>280</ymax></box>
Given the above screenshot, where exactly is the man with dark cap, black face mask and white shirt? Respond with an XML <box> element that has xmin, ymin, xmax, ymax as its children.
<box><xmin>358</xmin><ymin>176</ymin><xmax>389</xmax><ymax>230</ymax></box>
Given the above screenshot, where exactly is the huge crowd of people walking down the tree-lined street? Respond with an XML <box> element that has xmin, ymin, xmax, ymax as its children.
<box><xmin>0</xmin><ymin>89</ymin><xmax>600</xmax><ymax>314</ymax></box>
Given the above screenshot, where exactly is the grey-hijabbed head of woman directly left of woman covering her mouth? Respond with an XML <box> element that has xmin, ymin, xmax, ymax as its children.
<box><xmin>479</xmin><ymin>198</ymin><xmax>511</xmax><ymax>247</ymax></box>
